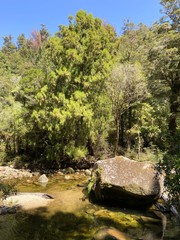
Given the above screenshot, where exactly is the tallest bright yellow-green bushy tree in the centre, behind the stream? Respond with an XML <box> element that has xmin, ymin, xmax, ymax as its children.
<box><xmin>17</xmin><ymin>11</ymin><xmax>116</xmax><ymax>164</ymax></box>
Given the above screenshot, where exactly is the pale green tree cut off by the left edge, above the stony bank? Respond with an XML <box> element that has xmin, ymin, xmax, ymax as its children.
<box><xmin>0</xmin><ymin>52</ymin><xmax>23</xmax><ymax>157</ymax></box>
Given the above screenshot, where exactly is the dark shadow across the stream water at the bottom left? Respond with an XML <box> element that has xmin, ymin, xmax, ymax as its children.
<box><xmin>0</xmin><ymin>205</ymin><xmax>129</xmax><ymax>240</ymax></box>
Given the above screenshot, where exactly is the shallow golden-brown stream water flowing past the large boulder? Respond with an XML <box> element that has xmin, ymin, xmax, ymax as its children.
<box><xmin>0</xmin><ymin>174</ymin><xmax>180</xmax><ymax>240</ymax></box>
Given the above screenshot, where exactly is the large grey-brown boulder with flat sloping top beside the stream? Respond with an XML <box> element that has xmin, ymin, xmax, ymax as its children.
<box><xmin>91</xmin><ymin>156</ymin><xmax>163</xmax><ymax>208</ymax></box>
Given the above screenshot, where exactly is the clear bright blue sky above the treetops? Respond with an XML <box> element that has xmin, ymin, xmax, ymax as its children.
<box><xmin>0</xmin><ymin>0</ymin><xmax>162</xmax><ymax>46</ymax></box>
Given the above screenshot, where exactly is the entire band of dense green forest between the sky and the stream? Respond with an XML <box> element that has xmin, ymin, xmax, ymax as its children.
<box><xmin>0</xmin><ymin>0</ymin><xmax>180</xmax><ymax>197</ymax></box>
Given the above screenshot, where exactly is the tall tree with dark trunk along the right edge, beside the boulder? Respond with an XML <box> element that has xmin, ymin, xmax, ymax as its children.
<box><xmin>149</xmin><ymin>0</ymin><xmax>180</xmax><ymax>199</ymax></box>
